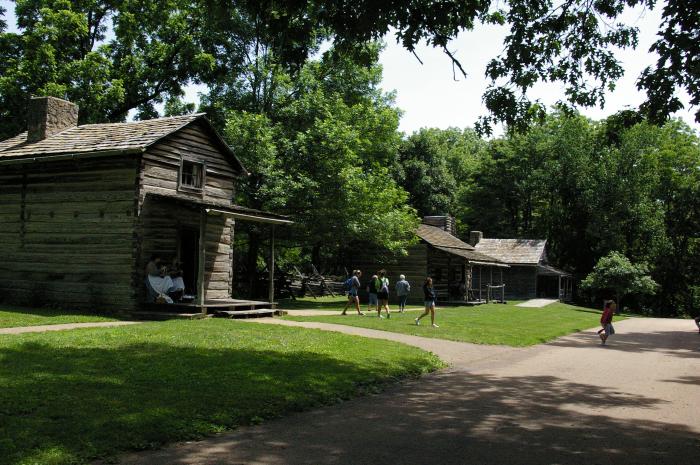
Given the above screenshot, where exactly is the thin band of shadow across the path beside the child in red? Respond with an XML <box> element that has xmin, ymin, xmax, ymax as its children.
<box><xmin>549</xmin><ymin>331</ymin><xmax>700</xmax><ymax>358</ymax></box>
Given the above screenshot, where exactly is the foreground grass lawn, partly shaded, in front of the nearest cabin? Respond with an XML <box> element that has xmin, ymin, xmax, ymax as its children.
<box><xmin>0</xmin><ymin>320</ymin><xmax>443</xmax><ymax>465</ymax></box>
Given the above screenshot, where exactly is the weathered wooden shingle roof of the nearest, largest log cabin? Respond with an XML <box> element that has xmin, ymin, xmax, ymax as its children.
<box><xmin>0</xmin><ymin>113</ymin><xmax>245</xmax><ymax>172</ymax></box>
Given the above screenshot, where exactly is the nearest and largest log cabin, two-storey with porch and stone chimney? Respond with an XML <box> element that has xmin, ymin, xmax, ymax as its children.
<box><xmin>0</xmin><ymin>97</ymin><xmax>290</xmax><ymax>312</ymax></box>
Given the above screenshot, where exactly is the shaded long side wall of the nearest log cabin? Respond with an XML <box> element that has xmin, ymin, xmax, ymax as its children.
<box><xmin>0</xmin><ymin>157</ymin><xmax>138</xmax><ymax>312</ymax></box>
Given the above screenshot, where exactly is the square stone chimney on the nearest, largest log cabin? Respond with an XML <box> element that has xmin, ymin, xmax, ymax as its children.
<box><xmin>27</xmin><ymin>97</ymin><xmax>78</xmax><ymax>142</ymax></box>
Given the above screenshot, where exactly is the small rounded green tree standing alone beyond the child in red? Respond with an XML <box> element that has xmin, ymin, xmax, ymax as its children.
<box><xmin>581</xmin><ymin>252</ymin><xmax>658</xmax><ymax>309</ymax></box>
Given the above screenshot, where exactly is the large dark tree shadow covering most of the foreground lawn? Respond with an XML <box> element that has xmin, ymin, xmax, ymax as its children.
<box><xmin>0</xmin><ymin>341</ymin><xmax>426</xmax><ymax>464</ymax></box>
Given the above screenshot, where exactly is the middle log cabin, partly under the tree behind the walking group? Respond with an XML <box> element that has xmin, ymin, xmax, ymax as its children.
<box><xmin>351</xmin><ymin>215</ymin><xmax>508</xmax><ymax>305</ymax></box>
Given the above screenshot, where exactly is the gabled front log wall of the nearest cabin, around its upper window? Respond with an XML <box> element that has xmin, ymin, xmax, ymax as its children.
<box><xmin>134</xmin><ymin>123</ymin><xmax>235</xmax><ymax>299</ymax></box>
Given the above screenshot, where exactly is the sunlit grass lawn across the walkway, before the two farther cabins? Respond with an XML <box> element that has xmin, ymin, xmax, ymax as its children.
<box><xmin>286</xmin><ymin>303</ymin><xmax>621</xmax><ymax>347</ymax></box>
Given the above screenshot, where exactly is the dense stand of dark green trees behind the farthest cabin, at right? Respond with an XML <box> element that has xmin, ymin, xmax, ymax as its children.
<box><xmin>408</xmin><ymin>111</ymin><xmax>700</xmax><ymax>314</ymax></box>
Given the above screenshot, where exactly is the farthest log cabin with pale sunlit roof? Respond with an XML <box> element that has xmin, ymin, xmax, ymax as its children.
<box><xmin>469</xmin><ymin>231</ymin><xmax>573</xmax><ymax>301</ymax></box>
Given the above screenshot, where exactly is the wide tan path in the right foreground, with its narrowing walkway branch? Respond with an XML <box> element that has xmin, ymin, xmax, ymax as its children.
<box><xmin>117</xmin><ymin>319</ymin><xmax>700</xmax><ymax>465</ymax></box>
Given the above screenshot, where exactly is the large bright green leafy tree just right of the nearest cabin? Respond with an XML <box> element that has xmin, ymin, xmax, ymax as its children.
<box><xmin>223</xmin><ymin>45</ymin><xmax>417</xmax><ymax>272</ymax></box>
